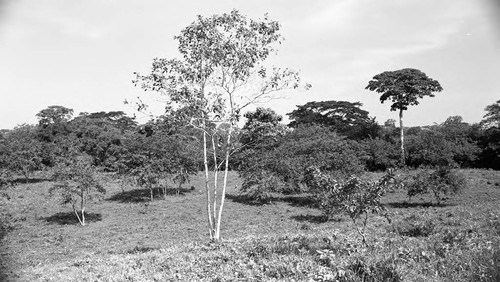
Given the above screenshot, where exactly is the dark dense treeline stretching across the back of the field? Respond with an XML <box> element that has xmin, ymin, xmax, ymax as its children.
<box><xmin>0</xmin><ymin>101</ymin><xmax>500</xmax><ymax>186</ymax></box>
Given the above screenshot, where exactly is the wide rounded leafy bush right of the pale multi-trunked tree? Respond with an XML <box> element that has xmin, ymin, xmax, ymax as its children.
<box><xmin>240</xmin><ymin>126</ymin><xmax>364</xmax><ymax>198</ymax></box>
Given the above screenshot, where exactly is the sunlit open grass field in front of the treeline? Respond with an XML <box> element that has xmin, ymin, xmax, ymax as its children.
<box><xmin>0</xmin><ymin>170</ymin><xmax>500</xmax><ymax>281</ymax></box>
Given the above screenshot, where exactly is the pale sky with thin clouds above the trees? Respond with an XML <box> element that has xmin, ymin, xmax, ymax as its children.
<box><xmin>0</xmin><ymin>0</ymin><xmax>500</xmax><ymax>128</ymax></box>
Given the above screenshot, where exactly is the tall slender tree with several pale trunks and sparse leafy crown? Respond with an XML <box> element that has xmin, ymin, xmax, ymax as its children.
<box><xmin>134</xmin><ymin>10</ymin><xmax>309</xmax><ymax>241</ymax></box>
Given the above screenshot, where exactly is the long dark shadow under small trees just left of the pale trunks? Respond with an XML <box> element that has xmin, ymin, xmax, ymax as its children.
<box><xmin>106</xmin><ymin>188</ymin><xmax>194</xmax><ymax>203</ymax></box>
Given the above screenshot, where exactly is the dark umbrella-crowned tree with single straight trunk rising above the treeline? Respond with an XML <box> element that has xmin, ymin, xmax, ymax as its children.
<box><xmin>365</xmin><ymin>68</ymin><xmax>443</xmax><ymax>166</ymax></box>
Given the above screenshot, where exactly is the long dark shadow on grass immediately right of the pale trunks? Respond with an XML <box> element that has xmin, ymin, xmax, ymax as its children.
<box><xmin>226</xmin><ymin>194</ymin><xmax>316</xmax><ymax>208</ymax></box>
